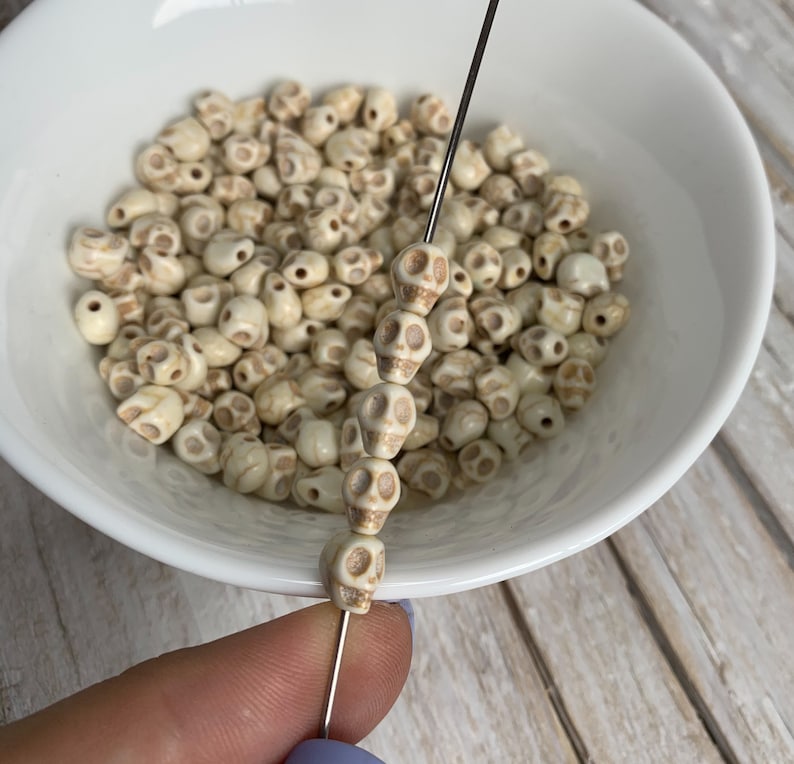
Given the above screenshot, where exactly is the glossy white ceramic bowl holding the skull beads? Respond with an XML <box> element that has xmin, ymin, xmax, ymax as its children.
<box><xmin>0</xmin><ymin>0</ymin><xmax>774</xmax><ymax>598</ymax></box>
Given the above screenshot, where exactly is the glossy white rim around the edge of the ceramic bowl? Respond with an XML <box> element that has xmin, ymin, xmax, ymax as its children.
<box><xmin>0</xmin><ymin>0</ymin><xmax>775</xmax><ymax>599</ymax></box>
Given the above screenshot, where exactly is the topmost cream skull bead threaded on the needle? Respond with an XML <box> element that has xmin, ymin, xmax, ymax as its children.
<box><xmin>391</xmin><ymin>243</ymin><xmax>449</xmax><ymax>316</ymax></box>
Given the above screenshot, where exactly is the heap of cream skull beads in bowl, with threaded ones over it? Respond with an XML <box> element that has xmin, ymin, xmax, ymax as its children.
<box><xmin>68</xmin><ymin>81</ymin><xmax>629</xmax><ymax>608</ymax></box>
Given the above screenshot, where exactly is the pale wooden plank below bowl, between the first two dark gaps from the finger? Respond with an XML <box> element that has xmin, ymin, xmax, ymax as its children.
<box><xmin>507</xmin><ymin>544</ymin><xmax>721</xmax><ymax>764</ymax></box>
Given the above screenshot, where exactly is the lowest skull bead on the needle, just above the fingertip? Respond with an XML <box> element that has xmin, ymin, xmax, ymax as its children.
<box><xmin>320</xmin><ymin>530</ymin><xmax>386</xmax><ymax>615</ymax></box>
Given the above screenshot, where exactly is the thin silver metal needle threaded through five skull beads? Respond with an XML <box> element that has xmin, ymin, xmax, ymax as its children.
<box><xmin>320</xmin><ymin>0</ymin><xmax>499</xmax><ymax>740</ymax></box>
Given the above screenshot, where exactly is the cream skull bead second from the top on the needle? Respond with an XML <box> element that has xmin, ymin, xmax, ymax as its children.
<box><xmin>372</xmin><ymin>310</ymin><xmax>433</xmax><ymax>385</ymax></box>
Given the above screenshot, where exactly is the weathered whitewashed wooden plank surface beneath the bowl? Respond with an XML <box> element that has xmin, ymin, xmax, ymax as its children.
<box><xmin>0</xmin><ymin>0</ymin><xmax>794</xmax><ymax>764</ymax></box>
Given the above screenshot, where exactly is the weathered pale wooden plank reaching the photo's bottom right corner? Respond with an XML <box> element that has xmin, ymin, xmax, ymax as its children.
<box><xmin>613</xmin><ymin>444</ymin><xmax>794</xmax><ymax>764</ymax></box>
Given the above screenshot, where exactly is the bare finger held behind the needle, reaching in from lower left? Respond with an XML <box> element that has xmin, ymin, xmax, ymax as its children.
<box><xmin>0</xmin><ymin>603</ymin><xmax>411</xmax><ymax>764</ymax></box>
